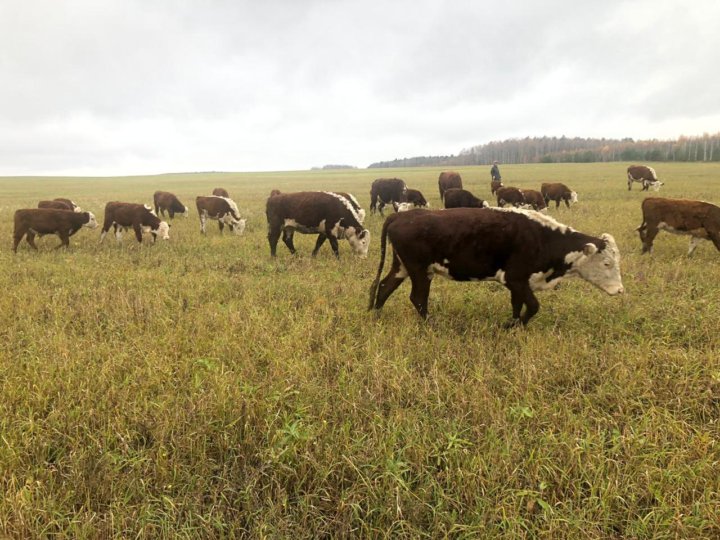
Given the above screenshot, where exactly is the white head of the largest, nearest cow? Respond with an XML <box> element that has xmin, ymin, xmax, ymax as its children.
<box><xmin>565</xmin><ymin>234</ymin><xmax>625</xmax><ymax>295</ymax></box>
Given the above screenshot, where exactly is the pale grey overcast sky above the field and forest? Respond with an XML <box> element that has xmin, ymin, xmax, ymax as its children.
<box><xmin>0</xmin><ymin>0</ymin><xmax>720</xmax><ymax>175</ymax></box>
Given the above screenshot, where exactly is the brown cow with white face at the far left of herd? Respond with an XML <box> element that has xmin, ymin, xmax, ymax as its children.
<box><xmin>13</xmin><ymin>208</ymin><xmax>97</xmax><ymax>253</ymax></box>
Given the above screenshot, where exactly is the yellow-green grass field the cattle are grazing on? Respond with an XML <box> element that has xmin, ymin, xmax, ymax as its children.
<box><xmin>0</xmin><ymin>163</ymin><xmax>720</xmax><ymax>538</ymax></box>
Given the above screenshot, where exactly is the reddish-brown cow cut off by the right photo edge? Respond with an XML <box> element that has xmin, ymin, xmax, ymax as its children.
<box><xmin>636</xmin><ymin>197</ymin><xmax>720</xmax><ymax>256</ymax></box>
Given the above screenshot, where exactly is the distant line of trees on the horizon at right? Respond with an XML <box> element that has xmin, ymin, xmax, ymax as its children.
<box><xmin>368</xmin><ymin>133</ymin><xmax>720</xmax><ymax>169</ymax></box>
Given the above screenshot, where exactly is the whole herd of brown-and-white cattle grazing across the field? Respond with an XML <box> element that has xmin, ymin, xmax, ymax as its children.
<box><xmin>8</xmin><ymin>166</ymin><xmax>720</xmax><ymax>325</ymax></box>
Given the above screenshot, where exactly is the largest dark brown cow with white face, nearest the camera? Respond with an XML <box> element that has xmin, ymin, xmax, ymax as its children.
<box><xmin>369</xmin><ymin>208</ymin><xmax>624</xmax><ymax>327</ymax></box>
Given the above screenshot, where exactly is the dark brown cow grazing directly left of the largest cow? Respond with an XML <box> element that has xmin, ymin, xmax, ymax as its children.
<box><xmin>265</xmin><ymin>191</ymin><xmax>370</xmax><ymax>258</ymax></box>
